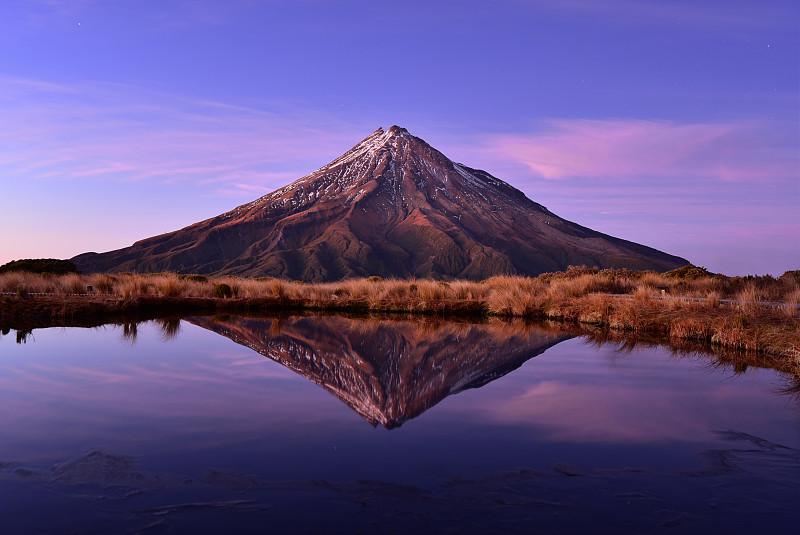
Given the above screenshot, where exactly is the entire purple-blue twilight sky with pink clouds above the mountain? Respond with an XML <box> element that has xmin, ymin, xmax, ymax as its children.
<box><xmin>0</xmin><ymin>0</ymin><xmax>800</xmax><ymax>275</ymax></box>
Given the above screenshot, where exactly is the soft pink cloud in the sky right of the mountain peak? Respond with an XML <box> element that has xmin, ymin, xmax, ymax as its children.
<box><xmin>489</xmin><ymin>119</ymin><xmax>800</xmax><ymax>181</ymax></box>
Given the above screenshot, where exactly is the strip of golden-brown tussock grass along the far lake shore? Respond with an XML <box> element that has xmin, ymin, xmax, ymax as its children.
<box><xmin>0</xmin><ymin>268</ymin><xmax>800</xmax><ymax>366</ymax></box>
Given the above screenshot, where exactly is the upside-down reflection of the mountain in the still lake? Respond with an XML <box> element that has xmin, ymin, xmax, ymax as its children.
<box><xmin>187</xmin><ymin>316</ymin><xmax>570</xmax><ymax>429</ymax></box>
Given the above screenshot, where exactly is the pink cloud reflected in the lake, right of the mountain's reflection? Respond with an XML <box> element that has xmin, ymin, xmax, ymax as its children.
<box><xmin>450</xmin><ymin>352</ymin><xmax>792</xmax><ymax>444</ymax></box>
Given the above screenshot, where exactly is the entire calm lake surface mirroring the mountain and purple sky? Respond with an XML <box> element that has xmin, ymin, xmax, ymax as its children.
<box><xmin>0</xmin><ymin>316</ymin><xmax>800</xmax><ymax>533</ymax></box>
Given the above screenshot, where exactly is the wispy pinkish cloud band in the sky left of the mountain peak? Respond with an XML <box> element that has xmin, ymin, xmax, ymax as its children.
<box><xmin>0</xmin><ymin>77</ymin><xmax>374</xmax><ymax>195</ymax></box>
